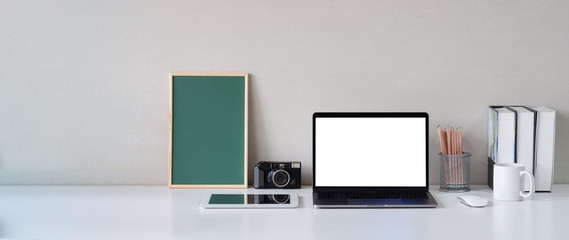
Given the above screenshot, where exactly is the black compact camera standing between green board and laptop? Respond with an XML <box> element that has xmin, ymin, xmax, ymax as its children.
<box><xmin>253</xmin><ymin>162</ymin><xmax>300</xmax><ymax>188</ymax></box>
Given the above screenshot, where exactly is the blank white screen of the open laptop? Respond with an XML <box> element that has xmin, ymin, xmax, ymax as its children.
<box><xmin>314</xmin><ymin>117</ymin><xmax>427</xmax><ymax>187</ymax></box>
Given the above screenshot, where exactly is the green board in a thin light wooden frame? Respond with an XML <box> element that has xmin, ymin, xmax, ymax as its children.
<box><xmin>168</xmin><ymin>73</ymin><xmax>248</xmax><ymax>188</ymax></box>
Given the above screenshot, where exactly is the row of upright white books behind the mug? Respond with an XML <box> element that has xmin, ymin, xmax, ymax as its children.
<box><xmin>488</xmin><ymin>106</ymin><xmax>555</xmax><ymax>191</ymax></box>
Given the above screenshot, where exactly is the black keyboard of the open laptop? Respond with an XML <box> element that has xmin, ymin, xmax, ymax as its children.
<box><xmin>318</xmin><ymin>192</ymin><xmax>428</xmax><ymax>199</ymax></box>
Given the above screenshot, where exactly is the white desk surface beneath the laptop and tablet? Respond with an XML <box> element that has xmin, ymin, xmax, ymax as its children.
<box><xmin>0</xmin><ymin>185</ymin><xmax>569</xmax><ymax>240</ymax></box>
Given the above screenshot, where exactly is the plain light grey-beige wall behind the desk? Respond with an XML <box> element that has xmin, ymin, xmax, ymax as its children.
<box><xmin>0</xmin><ymin>0</ymin><xmax>569</xmax><ymax>185</ymax></box>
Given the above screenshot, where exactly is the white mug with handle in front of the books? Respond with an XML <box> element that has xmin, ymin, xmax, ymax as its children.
<box><xmin>494</xmin><ymin>163</ymin><xmax>535</xmax><ymax>201</ymax></box>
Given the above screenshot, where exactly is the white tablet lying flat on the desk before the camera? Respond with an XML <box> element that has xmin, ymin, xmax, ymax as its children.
<box><xmin>201</xmin><ymin>193</ymin><xmax>298</xmax><ymax>208</ymax></box>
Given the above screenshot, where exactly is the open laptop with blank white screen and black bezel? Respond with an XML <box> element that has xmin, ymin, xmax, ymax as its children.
<box><xmin>312</xmin><ymin>112</ymin><xmax>438</xmax><ymax>208</ymax></box>
